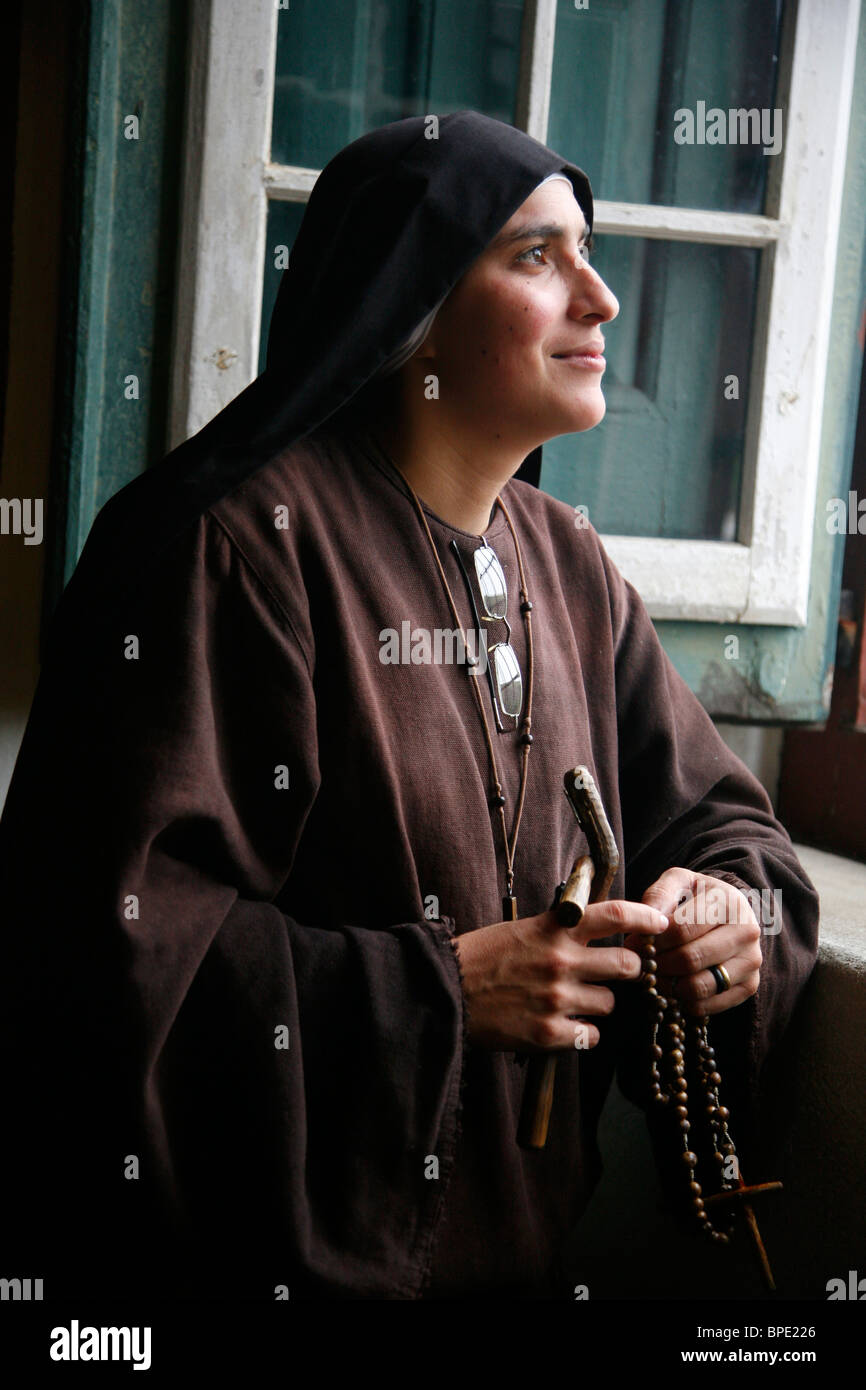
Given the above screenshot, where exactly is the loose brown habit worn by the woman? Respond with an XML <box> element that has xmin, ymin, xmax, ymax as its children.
<box><xmin>3</xmin><ymin>411</ymin><xmax>817</xmax><ymax>1300</ymax></box>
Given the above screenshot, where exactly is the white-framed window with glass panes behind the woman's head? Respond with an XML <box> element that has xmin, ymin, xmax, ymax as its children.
<box><xmin>172</xmin><ymin>0</ymin><xmax>859</xmax><ymax>626</ymax></box>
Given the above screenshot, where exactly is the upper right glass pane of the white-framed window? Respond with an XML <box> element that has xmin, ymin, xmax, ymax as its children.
<box><xmin>548</xmin><ymin>0</ymin><xmax>787</xmax><ymax>213</ymax></box>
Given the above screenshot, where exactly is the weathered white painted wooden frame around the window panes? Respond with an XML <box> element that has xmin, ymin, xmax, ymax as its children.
<box><xmin>171</xmin><ymin>0</ymin><xmax>860</xmax><ymax>627</ymax></box>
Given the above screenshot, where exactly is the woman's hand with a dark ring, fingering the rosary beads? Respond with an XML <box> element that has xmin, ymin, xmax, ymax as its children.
<box><xmin>624</xmin><ymin>869</ymin><xmax>763</xmax><ymax>1016</ymax></box>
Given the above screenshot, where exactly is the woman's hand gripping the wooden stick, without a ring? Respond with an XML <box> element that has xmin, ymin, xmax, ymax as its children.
<box><xmin>453</xmin><ymin>899</ymin><xmax>669</xmax><ymax>1052</ymax></box>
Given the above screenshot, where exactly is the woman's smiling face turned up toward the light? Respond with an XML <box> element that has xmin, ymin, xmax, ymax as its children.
<box><xmin>418</xmin><ymin>179</ymin><xmax>620</xmax><ymax>442</ymax></box>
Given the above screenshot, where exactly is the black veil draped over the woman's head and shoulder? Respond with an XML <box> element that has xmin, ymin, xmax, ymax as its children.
<box><xmin>60</xmin><ymin>110</ymin><xmax>592</xmax><ymax>633</ymax></box>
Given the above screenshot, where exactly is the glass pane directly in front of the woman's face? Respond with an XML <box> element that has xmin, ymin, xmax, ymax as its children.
<box><xmin>541</xmin><ymin>236</ymin><xmax>763</xmax><ymax>541</ymax></box>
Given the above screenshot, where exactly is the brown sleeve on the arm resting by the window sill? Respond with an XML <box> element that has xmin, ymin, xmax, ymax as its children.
<box><xmin>592</xmin><ymin>539</ymin><xmax>819</xmax><ymax>1134</ymax></box>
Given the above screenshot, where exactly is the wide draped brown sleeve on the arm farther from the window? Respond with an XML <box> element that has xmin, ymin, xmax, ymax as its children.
<box><xmin>0</xmin><ymin>514</ymin><xmax>464</xmax><ymax>1300</ymax></box>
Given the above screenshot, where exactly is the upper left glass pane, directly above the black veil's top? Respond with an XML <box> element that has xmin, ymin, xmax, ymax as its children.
<box><xmin>271</xmin><ymin>0</ymin><xmax>523</xmax><ymax>168</ymax></box>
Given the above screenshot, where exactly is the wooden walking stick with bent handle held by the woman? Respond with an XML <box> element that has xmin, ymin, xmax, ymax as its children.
<box><xmin>517</xmin><ymin>767</ymin><xmax>620</xmax><ymax>1148</ymax></box>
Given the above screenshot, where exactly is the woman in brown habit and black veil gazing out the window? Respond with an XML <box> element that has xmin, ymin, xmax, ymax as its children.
<box><xmin>0</xmin><ymin>111</ymin><xmax>816</xmax><ymax>1300</ymax></box>
